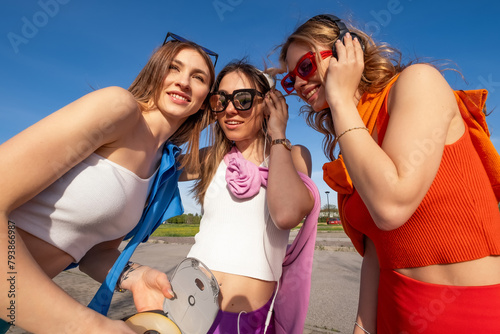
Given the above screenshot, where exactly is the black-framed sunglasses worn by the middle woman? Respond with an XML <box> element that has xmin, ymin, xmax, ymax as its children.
<box><xmin>208</xmin><ymin>88</ymin><xmax>264</xmax><ymax>112</ymax></box>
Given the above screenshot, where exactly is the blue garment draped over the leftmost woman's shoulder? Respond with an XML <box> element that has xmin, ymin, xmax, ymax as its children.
<box><xmin>0</xmin><ymin>143</ymin><xmax>184</xmax><ymax>334</ymax></box>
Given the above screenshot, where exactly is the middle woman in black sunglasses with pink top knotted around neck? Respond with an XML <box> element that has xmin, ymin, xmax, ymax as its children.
<box><xmin>182</xmin><ymin>62</ymin><xmax>319</xmax><ymax>333</ymax></box>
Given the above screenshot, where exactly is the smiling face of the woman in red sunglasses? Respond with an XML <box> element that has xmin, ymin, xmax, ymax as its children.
<box><xmin>286</xmin><ymin>43</ymin><xmax>330</xmax><ymax>111</ymax></box>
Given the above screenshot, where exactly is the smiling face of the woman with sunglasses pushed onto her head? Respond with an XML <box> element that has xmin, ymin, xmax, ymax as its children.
<box><xmin>157</xmin><ymin>48</ymin><xmax>210</xmax><ymax>121</ymax></box>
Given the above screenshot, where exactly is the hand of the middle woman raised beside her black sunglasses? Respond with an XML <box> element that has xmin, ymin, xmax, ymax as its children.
<box><xmin>264</xmin><ymin>89</ymin><xmax>288</xmax><ymax>139</ymax></box>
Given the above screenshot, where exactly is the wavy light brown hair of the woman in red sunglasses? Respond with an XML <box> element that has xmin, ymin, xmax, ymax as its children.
<box><xmin>278</xmin><ymin>15</ymin><xmax>407</xmax><ymax>160</ymax></box>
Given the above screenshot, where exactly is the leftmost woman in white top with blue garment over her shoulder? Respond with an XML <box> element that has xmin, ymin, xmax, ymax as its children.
<box><xmin>0</xmin><ymin>35</ymin><xmax>215</xmax><ymax>333</ymax></box>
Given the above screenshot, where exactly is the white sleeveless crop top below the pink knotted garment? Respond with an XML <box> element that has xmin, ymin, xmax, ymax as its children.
<box><xmin>188</xmin><ymin>161</ymin><xmax>289</xmax><ymax>281</ymax></box>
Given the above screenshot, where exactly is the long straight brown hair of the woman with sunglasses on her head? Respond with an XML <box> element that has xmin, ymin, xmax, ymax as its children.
<box><xmin>128</xmin><ymin>41</ymin><xmax>215</xmax><ymax>170</ymax></box>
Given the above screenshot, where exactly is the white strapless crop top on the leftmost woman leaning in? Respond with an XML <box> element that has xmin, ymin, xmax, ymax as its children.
<box><xmin>9</xmin><ymin>153</ymin><xmax>154</xmax><ymax>262</ymax></box>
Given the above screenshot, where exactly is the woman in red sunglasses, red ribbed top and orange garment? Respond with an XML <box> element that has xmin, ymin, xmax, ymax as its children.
<box><xmin>280</xmin><ymin>15</ymin><xmax>500</xmax><ymax>334</ymax></box>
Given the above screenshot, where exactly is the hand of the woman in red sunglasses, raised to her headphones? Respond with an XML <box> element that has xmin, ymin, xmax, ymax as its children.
<box><xmin>325</xmin><ymin>34</ymin><xmax>365</xmax><ymax>112</ymax></box>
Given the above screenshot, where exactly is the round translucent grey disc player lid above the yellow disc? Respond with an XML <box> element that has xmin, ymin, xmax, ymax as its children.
<box><xmin>163</xmin><ymin>258</ymin><xmax>219</xmax><ymax>334</ymax></box>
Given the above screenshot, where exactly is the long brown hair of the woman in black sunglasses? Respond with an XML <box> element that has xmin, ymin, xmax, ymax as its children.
<box><xmin>192</xmin><ymin>60</ymin><xmax>271</xmax><ymax>205</ymax></box>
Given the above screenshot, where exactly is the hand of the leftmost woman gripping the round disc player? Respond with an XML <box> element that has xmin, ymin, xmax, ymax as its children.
<box><xmin>121</xmin><ymin>264</ymin><xmax>174</xmax><ymax>312</ymax></box>
